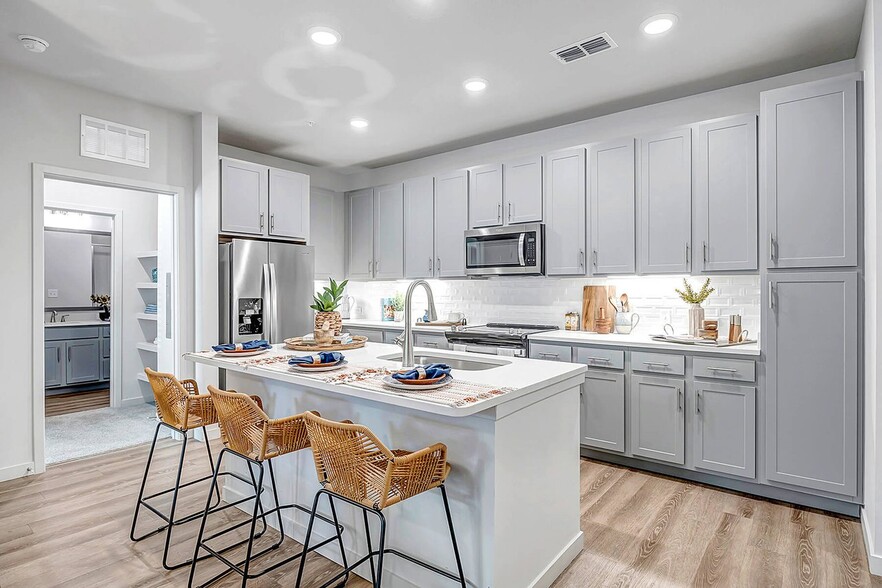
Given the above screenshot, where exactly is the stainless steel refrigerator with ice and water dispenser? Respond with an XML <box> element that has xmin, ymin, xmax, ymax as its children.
<box><xmin>218</xmin><ymin>239</ymin><xmax>315</xmax><ymax>343</ymax></box>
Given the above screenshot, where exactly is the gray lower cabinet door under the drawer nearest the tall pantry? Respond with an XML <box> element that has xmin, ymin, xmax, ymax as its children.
<box><xmin>693</xmin><ymin>384</ymin><xmax>756</xmax><ymax>478</ymax></box>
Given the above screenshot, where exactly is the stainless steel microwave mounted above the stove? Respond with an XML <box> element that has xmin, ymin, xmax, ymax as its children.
<box><xmin>465</xmin><ymin>223</ymin><xmax>545</xmax><ymax>276</ymax></box>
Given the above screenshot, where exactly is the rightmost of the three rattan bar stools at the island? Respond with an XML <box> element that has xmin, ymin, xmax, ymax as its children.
<box><xmin>296</xmin><ymin>413</ymin><xmax>466</xmax><ymax>588</ymax></box>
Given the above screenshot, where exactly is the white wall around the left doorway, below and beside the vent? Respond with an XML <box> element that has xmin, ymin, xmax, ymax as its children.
<box><xmin>0</xmin><ymin>64</ymin><xmax>193</xmax><ymax>480</ymax></box>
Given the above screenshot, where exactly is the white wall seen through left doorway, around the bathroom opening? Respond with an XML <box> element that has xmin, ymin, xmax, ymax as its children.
<box><xmin>44</xmin><ymin>179</ymin><xmax>159</xmax><ymax>405</ymax></box>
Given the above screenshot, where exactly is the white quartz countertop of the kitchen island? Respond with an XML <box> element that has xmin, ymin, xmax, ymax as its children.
<box><xmin>184</xmin><ymin>343</ymin><xmax>586</xmax><ymax>417</ymax></box>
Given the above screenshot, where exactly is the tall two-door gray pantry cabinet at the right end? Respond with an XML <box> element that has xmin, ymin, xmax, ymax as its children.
<box><xmin>760</xmin><ymin>75</ymin><xmax>862</xmax><ymax>501</ymax></box>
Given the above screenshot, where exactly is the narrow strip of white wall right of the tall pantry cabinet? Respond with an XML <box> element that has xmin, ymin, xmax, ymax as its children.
<box><xmin>856</xmin><ymin>0</ymin><xmax>882</xmax><ymax>575</ymax></box>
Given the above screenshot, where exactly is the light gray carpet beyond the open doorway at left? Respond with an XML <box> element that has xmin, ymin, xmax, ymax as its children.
<box><xmin>46</xmin><ymin>404</ymin><xmax>169</xmax><ymax>463</ymax></box>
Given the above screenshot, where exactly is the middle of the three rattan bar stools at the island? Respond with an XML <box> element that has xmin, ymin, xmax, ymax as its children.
<box><xmin>188</xmin><ymin>386</ymin><xmax>343</xmax><ymax>587</ymax></box>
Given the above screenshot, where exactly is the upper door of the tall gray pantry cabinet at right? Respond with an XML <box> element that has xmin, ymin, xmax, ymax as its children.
<box><xmin>760</xmin><ymin>76</ymin><xmax>858</xmax><ymax>268</ymax></box>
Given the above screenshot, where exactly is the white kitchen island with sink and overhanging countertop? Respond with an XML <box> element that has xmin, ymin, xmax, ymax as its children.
<box><xmin>185</xmin><ymin>343</ymin><xmax>585</xmax><ymax>588</ymax></box>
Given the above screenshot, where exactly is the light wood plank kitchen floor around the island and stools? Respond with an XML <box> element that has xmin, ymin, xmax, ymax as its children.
<box><xmin>0</xmin><ymin>439</ymin><xmax>882</xmax><ymax>588</ymax></box>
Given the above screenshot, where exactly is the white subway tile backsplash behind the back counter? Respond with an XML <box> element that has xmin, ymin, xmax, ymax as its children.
<box><xmin>334</xmin><ymin>274</ymin><xmax>760</xmax><ymax>338</ymax></box>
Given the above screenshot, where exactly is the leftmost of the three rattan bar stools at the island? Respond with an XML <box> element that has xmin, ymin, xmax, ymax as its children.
<box><xmin>129</xmin><ymin>368</ymin><xmax>266</xmax><ymax>570</ymax></box>
